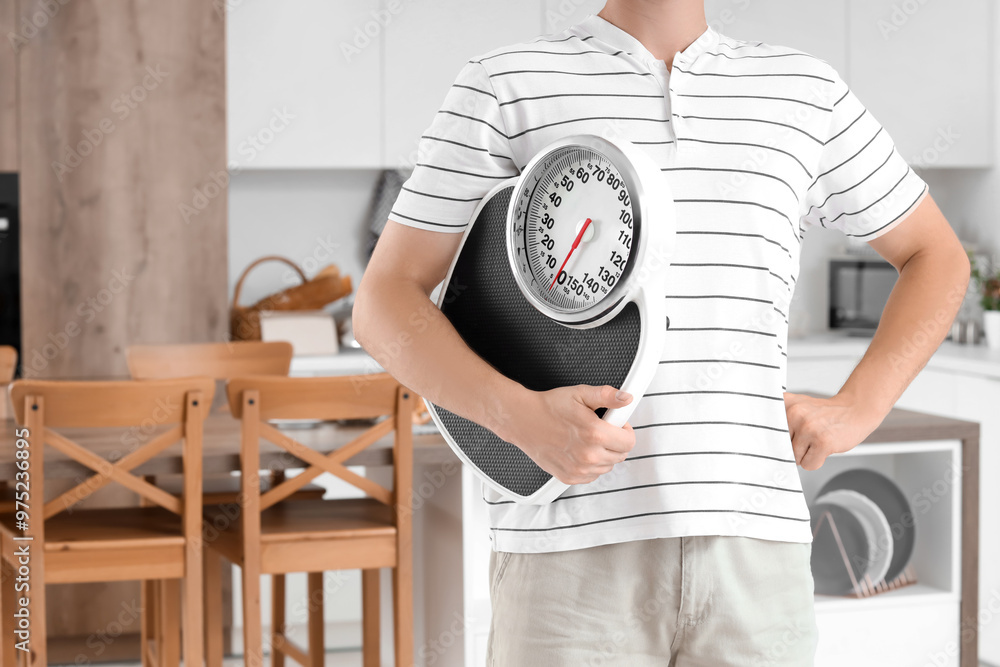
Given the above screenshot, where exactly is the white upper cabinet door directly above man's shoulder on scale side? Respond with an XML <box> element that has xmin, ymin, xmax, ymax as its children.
<box><xmin>383</xmin><ymin>0</ymin><xmax>542</xmax><ymax>167</ymax></box>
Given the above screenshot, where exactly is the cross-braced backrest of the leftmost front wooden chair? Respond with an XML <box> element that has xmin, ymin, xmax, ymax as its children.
<box><xmin>10</xmin><ymin>377</ymin><xmax>215</xmax><ymax>524</ymax></box>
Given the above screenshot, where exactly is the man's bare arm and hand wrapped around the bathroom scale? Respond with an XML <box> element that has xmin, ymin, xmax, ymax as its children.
<box><xmin>353</xmin><ymin>220</ymin><xmax>635</xmax><ymax>484</ymax></box>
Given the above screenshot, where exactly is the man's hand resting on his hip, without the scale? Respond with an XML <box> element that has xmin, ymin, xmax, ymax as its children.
<box><xmin>785</xmin><ymin>393</ymin><xmax>880</xmax><ymax>470</ymax></box>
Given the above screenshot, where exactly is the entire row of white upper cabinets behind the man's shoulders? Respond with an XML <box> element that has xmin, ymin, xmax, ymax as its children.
<box><xmin>225</xmin><ymin>0</ymin><xmax>994</xmax><ymax>168</ymax></box>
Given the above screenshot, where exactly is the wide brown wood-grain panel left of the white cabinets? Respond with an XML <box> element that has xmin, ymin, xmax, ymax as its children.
<box><xmin>18</xmin><ymin>0</ymin><xmax>228</xmax><ymax>378</ymax></box>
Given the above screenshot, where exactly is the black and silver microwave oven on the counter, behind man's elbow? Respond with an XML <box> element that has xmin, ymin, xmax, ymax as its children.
<box><xmin>829</xmin><ymin>256</ymin><xmax>899</xmax><ymax>334</ymax></box>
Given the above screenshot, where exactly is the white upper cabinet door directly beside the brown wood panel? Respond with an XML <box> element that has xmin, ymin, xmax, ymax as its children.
<box><xmin>228</xmin><ymin>0</ymin><xmax>382</xmax><ymax>170</ymax></box>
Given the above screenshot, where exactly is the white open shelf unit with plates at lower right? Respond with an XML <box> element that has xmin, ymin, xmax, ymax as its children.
<box><xmin>800</xmin><ymin>440</ymin><xmax>962</xmax><ymax>667</ymax></box>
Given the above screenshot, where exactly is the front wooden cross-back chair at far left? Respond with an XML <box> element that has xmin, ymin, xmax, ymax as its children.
<box><xmin>0</xmin><ymin>378</ymin><xmax>215</xmax><ymax>667</ymax></box>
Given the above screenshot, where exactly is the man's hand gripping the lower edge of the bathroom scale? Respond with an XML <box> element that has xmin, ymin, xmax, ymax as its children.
<box><xmin>493</xmin><ymin>385</ymin><xmax>635</xmax><ymax>484</ymax></box>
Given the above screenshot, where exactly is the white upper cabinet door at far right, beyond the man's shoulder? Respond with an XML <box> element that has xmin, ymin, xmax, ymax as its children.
<box><xmin>848</xmin><ymin>0</ymin><xmax>994</xmax><ymax>167</ymax></box>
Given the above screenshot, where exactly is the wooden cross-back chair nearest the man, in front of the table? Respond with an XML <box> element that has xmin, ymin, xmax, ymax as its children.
<box><xmin>206</xmin><ymin>373</ymin><xmax>416</xmax><ymax>667</ymax></box>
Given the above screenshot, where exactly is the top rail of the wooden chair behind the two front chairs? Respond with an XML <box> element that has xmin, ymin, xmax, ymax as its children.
<box><xmin>126</xmin><ymin>341</ymin><xmax>292</xmax><ymax>380</ymax></box>
